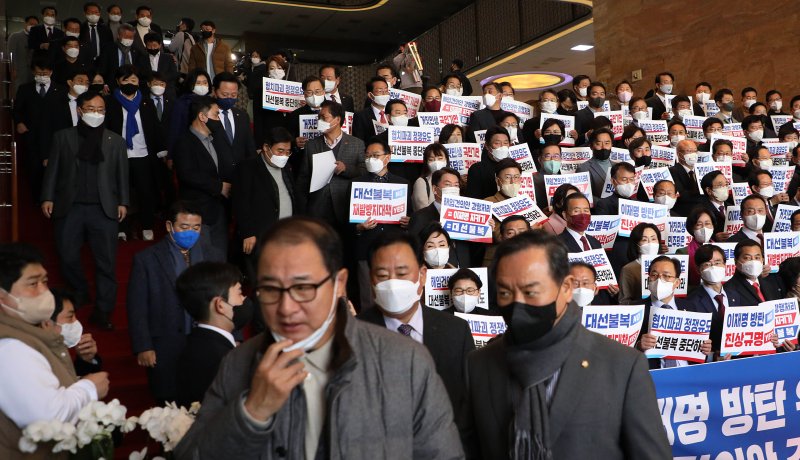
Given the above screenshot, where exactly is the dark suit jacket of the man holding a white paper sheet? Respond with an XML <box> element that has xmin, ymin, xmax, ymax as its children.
<box><xmin>295</xmin><ymin>133</ymin><xmax>367</xmax><ymax>224</ymax></box>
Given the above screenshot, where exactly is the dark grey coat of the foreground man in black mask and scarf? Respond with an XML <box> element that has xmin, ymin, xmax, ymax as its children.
<box><xmin>462</xmin><ymin>326</ymin><xmax>672</xmax><ymax>460</ymax></box>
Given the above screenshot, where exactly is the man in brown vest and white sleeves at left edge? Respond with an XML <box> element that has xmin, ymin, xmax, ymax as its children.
<box><xmin>0</xmin><ymin>243</ymin><xmax>109</xmax><ymax>459</ymax></box>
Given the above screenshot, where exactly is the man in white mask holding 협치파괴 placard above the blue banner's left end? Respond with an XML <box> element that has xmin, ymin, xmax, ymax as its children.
<box><xmin>636</xmin><ymin>256</ymin><xmax>711</xmax><ymax>369</ymax></box>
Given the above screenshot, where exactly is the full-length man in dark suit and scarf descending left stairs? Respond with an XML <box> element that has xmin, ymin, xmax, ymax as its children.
<box><xmin>41</xmin><ymin>91</ymin><xmax>130</xmax><ymax>329</ymax></box>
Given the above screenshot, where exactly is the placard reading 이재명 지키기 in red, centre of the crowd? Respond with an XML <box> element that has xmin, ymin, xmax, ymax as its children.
<box><xmin>439</xmin><ymin>195</ymin><xmax>492</xmax><ymax>244</ymax></box>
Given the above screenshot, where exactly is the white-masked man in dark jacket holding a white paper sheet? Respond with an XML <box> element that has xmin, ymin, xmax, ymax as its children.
<box><xmin>295</xmin><ymin>98</ymin><xmax>368</xmax><ymax>232</ymax></box>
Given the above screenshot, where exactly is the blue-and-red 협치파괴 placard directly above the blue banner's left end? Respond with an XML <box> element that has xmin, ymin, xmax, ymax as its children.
<box><xmin>644</xmin><ymin>308</ymin><xmax>711</xmax><ymax>363</ymax></box>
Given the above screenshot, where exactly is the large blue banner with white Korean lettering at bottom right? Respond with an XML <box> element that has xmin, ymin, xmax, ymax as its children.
<box><xmin>651</xmin><ymin>352</ymin><xmax>800</xmax><ymax>460</ymax></box>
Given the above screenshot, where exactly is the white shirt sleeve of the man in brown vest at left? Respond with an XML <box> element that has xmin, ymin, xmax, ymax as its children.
<box><xmin>0</xmin><ymin>338</ymin><xmax>97</xmax><ymax>428</ymax></box>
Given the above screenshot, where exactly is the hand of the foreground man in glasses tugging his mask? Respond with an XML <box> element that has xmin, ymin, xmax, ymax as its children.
<box><xmin>244</xmin><ymin>340</ymin><xmax>308</xmax><ymax>422</ymax></box>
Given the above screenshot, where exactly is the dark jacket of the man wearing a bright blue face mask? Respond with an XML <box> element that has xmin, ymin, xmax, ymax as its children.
<box><xmin>126</xmin><ymin>232</ymin><xmax>225</xmax><ymax>356</ymax></box>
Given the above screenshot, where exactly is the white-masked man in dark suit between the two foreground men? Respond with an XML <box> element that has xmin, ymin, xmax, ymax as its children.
<box><xmin>358</xmin><ymin>232</ymin><xmax>475</xmax><ymax>426</ymax></box>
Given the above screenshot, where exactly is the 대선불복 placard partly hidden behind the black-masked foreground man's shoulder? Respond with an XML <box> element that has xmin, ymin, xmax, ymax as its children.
<box><xmin>581</xmin><ymin>305</ymin><xmax>644</xmax><ymax>347</ymax></box>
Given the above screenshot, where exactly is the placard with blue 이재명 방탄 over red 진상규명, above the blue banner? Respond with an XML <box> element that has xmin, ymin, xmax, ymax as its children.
<box><xmin>719</xmin><ymin>304</ymin><xmax>775</xmax><ymax>356</ymax></box>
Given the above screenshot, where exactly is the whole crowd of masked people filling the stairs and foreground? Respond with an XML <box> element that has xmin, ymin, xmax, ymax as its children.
<box><xmin>0</xmin><ymin>2</ymin><xmax>800</xmax><ymax>459</ymax></box>
